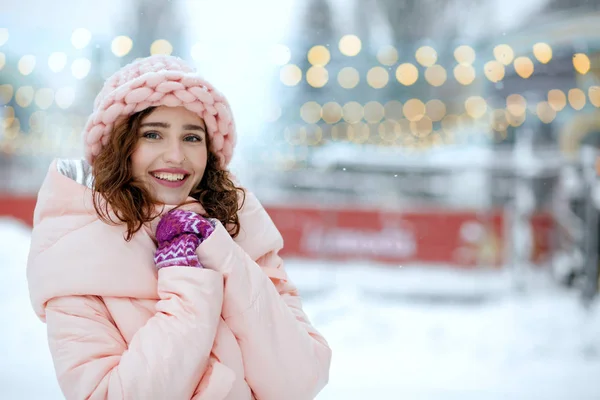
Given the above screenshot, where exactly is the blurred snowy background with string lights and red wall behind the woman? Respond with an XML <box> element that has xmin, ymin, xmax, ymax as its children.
<box><xmin>0</xmin><ymin>0</ymin><xmax>600</xmax><ymax>399</ymax></box>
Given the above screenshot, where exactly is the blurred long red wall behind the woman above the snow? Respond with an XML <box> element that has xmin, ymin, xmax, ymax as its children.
<box><xmin>0</xmin><ymin>195</ymin><xmax>552</xmax><ymax>267</ymax></box>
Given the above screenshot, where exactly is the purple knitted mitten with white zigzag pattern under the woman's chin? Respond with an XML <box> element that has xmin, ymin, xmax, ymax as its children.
<box><xmin>154</xmin><ymin>209</ymin><xmax>215</xmax><ymax>269</ymax></box>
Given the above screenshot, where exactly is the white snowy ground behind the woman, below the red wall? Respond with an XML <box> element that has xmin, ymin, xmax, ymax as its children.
<box><xmin>0</xmin><ymin>220</ymin><xmax>600</xmax><ymax>400</ymax></box>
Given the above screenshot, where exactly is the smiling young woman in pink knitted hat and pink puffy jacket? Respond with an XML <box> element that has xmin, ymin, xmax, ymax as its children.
<box><xmin>27</xmin><ymin>56</ymin><xmax>331</xmax><ymax>400</ymax></box>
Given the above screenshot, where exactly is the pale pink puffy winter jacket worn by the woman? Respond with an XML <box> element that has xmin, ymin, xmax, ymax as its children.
<box><xmin>27</xmin><ymin>162</ymin><xmax>331</xmax><ymax>400</ymax></box>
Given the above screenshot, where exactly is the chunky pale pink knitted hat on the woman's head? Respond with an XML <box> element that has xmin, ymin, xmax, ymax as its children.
<box><xmin>83</xmin><ymin>55</ymin><xmax>236</xmax><ymax>167</ymax></box>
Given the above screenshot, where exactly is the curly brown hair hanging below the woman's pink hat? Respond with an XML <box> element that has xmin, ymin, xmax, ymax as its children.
<box><xmin>92</xmin><ymin>107</ymin><xmax>246</xmax><ymax>241</ymax></box>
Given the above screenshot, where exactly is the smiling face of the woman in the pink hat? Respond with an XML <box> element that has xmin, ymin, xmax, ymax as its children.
<box><xmin>131</xmin><ymin>106</ymin><xmax>208</xmax><ymax>205</ymax></box>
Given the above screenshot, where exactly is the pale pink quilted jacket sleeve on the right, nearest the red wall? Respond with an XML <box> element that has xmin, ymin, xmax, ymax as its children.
<box><xmin>197</xmin><ymin>224</ymin><xmax>331</xmax><ymax>400</ymax></box>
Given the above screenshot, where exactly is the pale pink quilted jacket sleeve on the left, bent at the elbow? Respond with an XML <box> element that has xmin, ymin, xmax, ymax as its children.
<box><xmin>46</xmin><ymin>267</ymin><xmax>223</xmax><ymax>400</ymax></box>
